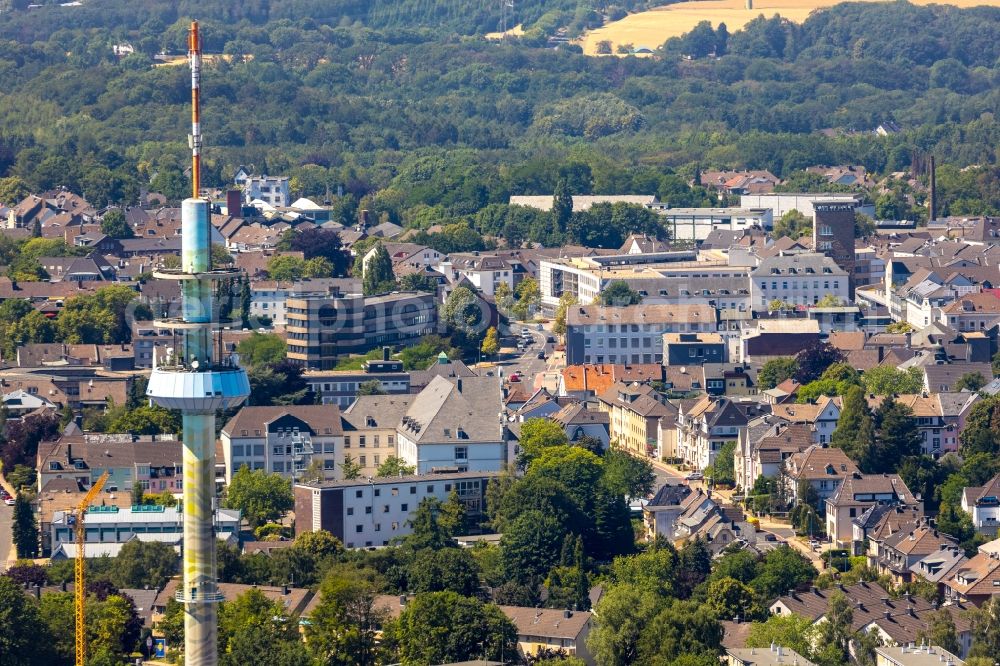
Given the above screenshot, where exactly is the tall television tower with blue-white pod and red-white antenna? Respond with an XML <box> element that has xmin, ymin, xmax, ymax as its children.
<box><xmin>146</xmin><ymin>21</ymin><xmax>250</xmax><ymax>666</ymax></box>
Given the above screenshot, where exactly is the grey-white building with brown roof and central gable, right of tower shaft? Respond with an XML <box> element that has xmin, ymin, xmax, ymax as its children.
<box><xmin>219</xmin><ymin>405</ymin><xmax>344</xmax><ymax>484</ymax></box>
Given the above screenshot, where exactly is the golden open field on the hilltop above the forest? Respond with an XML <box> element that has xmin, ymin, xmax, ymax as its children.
<box><xmin>580</xmin><ymin>0</ymin><xmax>1000</xmax><ymax>55</ymax></box>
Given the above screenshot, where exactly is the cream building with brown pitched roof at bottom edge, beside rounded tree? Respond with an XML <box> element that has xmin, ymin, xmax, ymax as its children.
<box><xmin>500</xmin><ymin>606</ymin><xmax>596</xmax><ymax>666</ymax></box>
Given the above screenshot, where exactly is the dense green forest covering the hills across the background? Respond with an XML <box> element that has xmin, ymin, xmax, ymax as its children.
<box><xmin>0</xmin><ymin>0</ymin><xmax>1000</xmax><ymax>231</ymax></box>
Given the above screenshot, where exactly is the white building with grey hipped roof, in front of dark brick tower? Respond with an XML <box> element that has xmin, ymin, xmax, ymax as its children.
<box><xmin>750</xmin><ymin>252</ymin><xmax>851</xmax><ymax>311</ymax></box>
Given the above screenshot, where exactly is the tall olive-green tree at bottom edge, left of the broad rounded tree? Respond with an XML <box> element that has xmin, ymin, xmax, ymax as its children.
<box><xmin>306</xmin><ymin>568</ymin><xmax>387</xmax><ymax>666</ymax></box>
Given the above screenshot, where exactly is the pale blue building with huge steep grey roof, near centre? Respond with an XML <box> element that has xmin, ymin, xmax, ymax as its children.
<box><xmin>396</xmin><ymin>376</ymin><xmax>507</xmax><ymax>474</ymax></box>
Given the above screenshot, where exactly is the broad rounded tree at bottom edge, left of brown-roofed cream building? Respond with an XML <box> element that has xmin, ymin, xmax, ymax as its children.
<box><xmin>386</xmin><ymin>592</ymin><xmax>517</xmax><ymax>664</ymax></box>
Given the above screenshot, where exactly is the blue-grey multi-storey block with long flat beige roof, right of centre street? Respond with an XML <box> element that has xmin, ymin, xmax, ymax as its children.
<box><xmin>566</xmin><ymin>303</ymin><xmax>723</xmax><ymax>365</ymax></box>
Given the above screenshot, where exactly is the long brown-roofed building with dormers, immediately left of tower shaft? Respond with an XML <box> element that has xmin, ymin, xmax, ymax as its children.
<box><xmin>36</xmin><ymin>431</ymin><xmax>184</xmax><ymax>493</ymax></box>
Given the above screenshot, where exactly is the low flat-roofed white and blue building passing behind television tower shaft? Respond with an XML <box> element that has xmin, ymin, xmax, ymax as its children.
<box><xmin>49</xmin><ymin>505</ymin><xmax>240</xmax><ymax>556</ymax></box>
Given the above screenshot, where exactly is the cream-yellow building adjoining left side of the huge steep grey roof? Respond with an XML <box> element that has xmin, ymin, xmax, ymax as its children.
<box><xmin>341</xmin><ymin>395</ymin><xmax>413</xmax><ymax>476</ymax></box>
